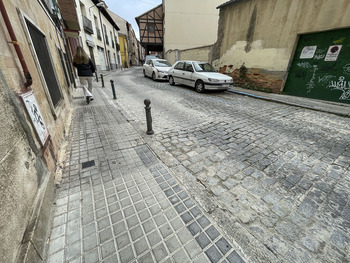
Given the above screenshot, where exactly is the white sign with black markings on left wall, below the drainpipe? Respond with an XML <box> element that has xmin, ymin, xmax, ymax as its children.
<box><xmin>20</xmin><ymin>90</ymin><xmax>49</xmax><ymax>146</ymax></box>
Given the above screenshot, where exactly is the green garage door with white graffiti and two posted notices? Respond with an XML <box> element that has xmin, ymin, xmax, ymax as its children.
<box><xmin>284</xmin><ymin>28</ymin><xmax>350</xmax><ymax>104</ymax></box>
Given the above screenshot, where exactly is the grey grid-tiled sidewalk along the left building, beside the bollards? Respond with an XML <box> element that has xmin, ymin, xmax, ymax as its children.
<box><xmin>46</xmin><ymin>82</ymin><xmax>244</xmax><ymax>263</ymax></box>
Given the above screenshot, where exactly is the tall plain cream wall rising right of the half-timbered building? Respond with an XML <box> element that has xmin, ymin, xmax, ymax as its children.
<box><xmin>163</xmin><ymin>0</ymin><xmax>223</xmax><ymax>52</ymax></box>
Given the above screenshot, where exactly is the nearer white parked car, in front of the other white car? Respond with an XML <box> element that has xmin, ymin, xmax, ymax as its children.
<box><xmin>168</xmin><ymin>61</ymin><xmax>233</xmax><ymax>92</ymax></box>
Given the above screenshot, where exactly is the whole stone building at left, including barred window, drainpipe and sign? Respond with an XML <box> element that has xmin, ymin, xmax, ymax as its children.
<box><xmin>0</xmin><ymin>0</ymin><xmax>74</xmax><ymax>262</ymax></box>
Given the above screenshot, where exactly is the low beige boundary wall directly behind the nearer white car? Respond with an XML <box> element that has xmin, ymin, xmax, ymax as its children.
<box><xmin>165</xmin><ymin>46</ymin><xmax>211</xmax><ymax>64</ymax></box>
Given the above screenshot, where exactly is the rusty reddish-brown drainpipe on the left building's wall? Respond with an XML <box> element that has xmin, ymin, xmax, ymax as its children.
<box><xmin>0</xmin><ymin>0</ymin><xmax>33</xmax><ymax>91</ymax></box>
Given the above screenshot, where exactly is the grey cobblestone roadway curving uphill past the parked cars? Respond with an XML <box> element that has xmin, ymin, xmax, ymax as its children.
<box><xmin>103</xmin><ymin>68</ymin><xmax>350</xmax><ymax>262</ymax></box>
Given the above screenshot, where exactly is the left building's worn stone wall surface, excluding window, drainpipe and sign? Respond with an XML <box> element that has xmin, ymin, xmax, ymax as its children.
<box><xmin>0</xmin><ymin>0</ymin><xmax>71</xmax><ymax>262</ymax></box>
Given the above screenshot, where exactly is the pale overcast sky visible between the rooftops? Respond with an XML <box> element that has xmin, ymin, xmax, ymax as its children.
<box><xmin>104</xmin><ymin>0</ymin><xmax>162</xmax><ymax>40</ymax></box>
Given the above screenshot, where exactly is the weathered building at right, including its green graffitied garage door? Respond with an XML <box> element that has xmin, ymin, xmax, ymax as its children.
<box><xmin>213</xmin><ymin>0</ymin><xmax>350</xmax><ymax>103</ymax></box>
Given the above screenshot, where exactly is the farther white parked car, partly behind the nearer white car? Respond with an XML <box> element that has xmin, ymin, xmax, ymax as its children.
<box><xmin>143</xmin><ymin>58</ymin><xmax>171</xmax><ymax>80</ymax></box>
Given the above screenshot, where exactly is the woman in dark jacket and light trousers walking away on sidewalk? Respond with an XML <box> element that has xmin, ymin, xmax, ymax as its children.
<box><xmin>73</xmin><ymin>46</ymin><xmax>96</xmax><ymax>103</ymax></box>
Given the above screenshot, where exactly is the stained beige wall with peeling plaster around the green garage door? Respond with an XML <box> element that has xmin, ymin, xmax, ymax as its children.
<box><xmin>213</xmin><ymin>0</ymin><xmax>350</xmax><ymax>93</ymax></box>
